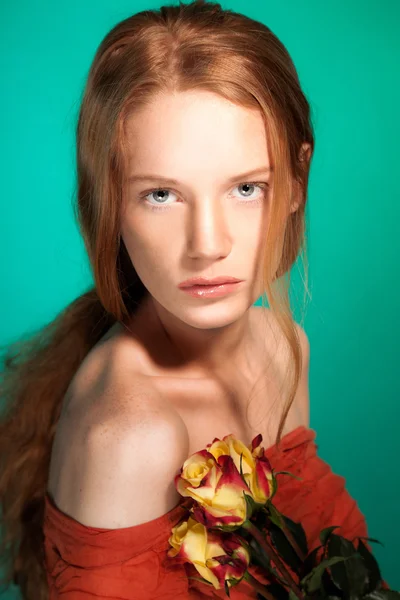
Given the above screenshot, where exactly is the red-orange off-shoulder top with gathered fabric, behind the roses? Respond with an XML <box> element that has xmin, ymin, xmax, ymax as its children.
<box><xmin>44</xmin><ymin>425</ymin><xmax>388</xmax><ymax>600</ymax></box>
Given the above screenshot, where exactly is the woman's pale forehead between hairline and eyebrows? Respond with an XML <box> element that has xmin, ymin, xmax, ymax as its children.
<box><xmin>126</xmin><ymin>91</ymin><xmax>269</xmax><ymax>173</ymax></box>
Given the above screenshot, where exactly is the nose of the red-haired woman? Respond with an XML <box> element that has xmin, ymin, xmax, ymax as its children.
<box><xmin>187</xmin><ymin>198</ymin><xmax>232</xmax><ymax>260</ymax></box>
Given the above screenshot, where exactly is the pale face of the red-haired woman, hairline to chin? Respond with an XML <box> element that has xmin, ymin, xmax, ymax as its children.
<box><xmin>121</xmin><ymin>91</ymin><xmax>273</xmax><ymax>327</ymax></box>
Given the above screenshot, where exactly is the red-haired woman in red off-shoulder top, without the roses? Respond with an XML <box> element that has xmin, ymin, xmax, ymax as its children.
<box><xmin>0</xmin><ymin>0</ymin><xmax>384</xmax><ymax>600</ymax></box>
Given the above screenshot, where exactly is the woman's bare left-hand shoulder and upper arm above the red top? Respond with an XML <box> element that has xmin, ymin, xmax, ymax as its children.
<box><xmin>48</xmin><ymin>338</ymin><xmax>189</xmax><ymax>529</ymax></box>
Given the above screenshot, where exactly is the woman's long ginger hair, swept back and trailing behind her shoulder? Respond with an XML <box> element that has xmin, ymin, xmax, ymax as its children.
<box><xmin>0</xmin><ymin>0</ymin><xmax>314</xmax><ymax>600</ymax></box>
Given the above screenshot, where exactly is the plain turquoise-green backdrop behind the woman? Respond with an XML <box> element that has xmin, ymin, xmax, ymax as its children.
<box><xmin>0</xmin><ymin>0</ymin><xmax>400</xmax><ymax>600</ymax></box>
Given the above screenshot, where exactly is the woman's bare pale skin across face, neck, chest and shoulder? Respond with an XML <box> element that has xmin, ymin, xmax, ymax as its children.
<box><xmin>48</xmin><ymin>91</ymin><xmax>310</xmax><ymax>528</ymax></box>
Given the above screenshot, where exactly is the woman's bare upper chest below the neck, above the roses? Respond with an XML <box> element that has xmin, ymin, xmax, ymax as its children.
<box><xmin>148</xmin><ymin>346</ymin><xmax>301</xmax><ymax>455</ymax></box>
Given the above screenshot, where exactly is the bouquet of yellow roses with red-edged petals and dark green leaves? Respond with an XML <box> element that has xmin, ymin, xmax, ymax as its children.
<box><xmin>167</xmin><ymin>434</ymin><xmax>400</xmax><ymax>600</ymax></box>
